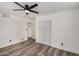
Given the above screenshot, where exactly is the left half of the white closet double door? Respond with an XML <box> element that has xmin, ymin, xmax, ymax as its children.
<box><xmin>38</xmin><ymin>21</ymin><xmax>45</xmax><ymax>44</ymax></box>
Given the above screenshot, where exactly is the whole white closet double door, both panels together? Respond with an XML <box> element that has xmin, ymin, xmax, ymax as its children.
<box><xmin>38</xmin><ymin>20</ymin><xmax>51</xmax><ymax>45</ymax></box>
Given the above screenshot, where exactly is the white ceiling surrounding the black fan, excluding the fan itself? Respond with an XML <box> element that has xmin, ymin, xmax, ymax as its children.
<box><xmin>0</xmin><ymin>2</ymin><xmax>79</xmax><ymax>16</ymax></box>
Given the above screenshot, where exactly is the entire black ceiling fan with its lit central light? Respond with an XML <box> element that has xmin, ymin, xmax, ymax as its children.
<box><xmin>13</xmin><ymin>2</ymin><xmax>39</xmax><ymax>15</ymax></box>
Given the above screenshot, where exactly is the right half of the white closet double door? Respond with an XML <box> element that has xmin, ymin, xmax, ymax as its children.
<box><xmin>44</xmin><ymin>20</ymin><xmax>51</xmax><ymax>45</ymax></box>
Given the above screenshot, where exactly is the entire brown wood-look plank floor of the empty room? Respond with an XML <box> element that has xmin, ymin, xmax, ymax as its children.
<box><xmin>0</xmin><ymin>39</ymin><xmax>79</xmax><ymax>56</ymax></box>
